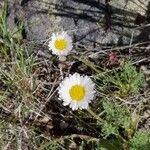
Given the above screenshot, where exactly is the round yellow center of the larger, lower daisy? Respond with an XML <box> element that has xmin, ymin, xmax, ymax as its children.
<box><xmin>69</xmin><ymin>85</ymin><xmax>85</xmax><ymax>101</ymax></box>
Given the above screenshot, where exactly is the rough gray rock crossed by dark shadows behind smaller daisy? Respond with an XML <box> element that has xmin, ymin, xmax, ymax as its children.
<box><xmin>8</xmin><ymin>0</ymin><xmax>147</xmax><ymax>47</ymax></box>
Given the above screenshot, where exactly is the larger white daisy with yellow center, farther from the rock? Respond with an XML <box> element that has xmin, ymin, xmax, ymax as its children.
<box><xmin>58</xmin><ymin>73</ymin><xmax>95</xmax><ymax>110</ymax></box>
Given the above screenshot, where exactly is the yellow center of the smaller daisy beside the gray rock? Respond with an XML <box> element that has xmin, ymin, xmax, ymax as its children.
<box><xmin>55</xmin><ymin>39</ymin><xmax>68</xmax><ymax>51</ymax></box>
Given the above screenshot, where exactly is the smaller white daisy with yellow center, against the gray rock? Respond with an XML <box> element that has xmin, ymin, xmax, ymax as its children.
<box><xmin>48</xmin><ymin>32</ymin><xmax>73</xmax><ymax>56</ymax></box>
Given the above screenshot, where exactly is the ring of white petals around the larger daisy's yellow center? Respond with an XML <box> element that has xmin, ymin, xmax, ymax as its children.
<box><xmin>58</xmin><ymin>73</ymin><xmax>95</xmax><ymax>110</ymax></box>
